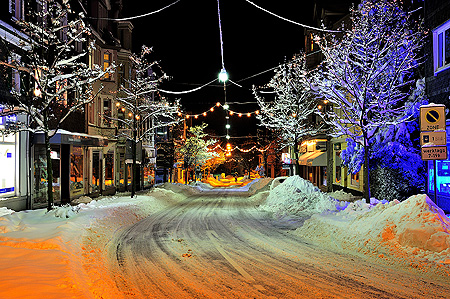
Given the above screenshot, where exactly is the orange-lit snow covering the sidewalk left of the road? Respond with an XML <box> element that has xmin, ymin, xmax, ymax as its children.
<box><xmin>0</xmin><ymin>189</ymin><xmax>184</xmax><ymax>299</ymax></box>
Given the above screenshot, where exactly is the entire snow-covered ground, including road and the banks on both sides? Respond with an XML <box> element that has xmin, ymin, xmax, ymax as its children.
<box><xmin>0</xmin><ymin>176</ymin><xmax>450</xmax><ymax>298</ymax></box>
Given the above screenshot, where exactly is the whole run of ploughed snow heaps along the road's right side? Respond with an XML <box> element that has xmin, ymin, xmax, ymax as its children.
<box><xmin>261</xmin><ymin>176</ymin><xmax>450</xmax><ymax>264</ymax></box>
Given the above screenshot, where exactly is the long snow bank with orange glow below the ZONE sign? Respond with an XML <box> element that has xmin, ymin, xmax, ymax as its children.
<box><xmin>296</xmin><ymin>194</ymin><xmax>450</xmax><ymax>265</ymax></box>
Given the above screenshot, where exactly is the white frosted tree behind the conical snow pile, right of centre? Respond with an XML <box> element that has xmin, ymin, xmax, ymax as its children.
<box><xmin>253</xmin><ymin>54</ymin><xmax>322</xmax><ymax>173</ymax></box>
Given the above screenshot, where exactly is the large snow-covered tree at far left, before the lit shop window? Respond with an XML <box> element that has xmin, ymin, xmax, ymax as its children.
<box><xmin>1</xmin><ymin>0</ymin><xmax>107</xmax><ymax>210</ymax></box>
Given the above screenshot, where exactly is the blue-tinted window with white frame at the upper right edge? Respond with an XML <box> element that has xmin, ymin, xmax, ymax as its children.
<box><xmin>433</xmin><ymin>20</ymin><xmax>450</xmax><ymax>74</ymax></box>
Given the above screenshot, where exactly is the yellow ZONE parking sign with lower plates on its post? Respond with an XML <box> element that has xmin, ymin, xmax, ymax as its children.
<box><xmin>420</xmin><ymin>104</ymin><xmax>447</xmax><ymax>203</ymax></box>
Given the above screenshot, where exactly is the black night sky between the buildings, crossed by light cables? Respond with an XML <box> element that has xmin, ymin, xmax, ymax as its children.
<box><xmin>123</xmin><ymin>0</ymin><xmax>313</xmax><ymax>136</ymax></box>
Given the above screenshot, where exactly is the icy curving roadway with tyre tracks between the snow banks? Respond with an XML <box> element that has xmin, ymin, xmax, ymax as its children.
<box><xmin>109</xmin><ymin>192</ymin><xmax>450</xmax><ymax>299</ymax></box>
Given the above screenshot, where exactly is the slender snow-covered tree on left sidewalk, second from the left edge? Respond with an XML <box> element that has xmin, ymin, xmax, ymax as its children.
<box><xmin>111</xmin><ymin>45</ymin><xmax>179</xmax><ymax>197</ymax></box>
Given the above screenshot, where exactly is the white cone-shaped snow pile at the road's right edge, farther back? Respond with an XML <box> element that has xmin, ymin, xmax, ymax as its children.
<box><xmin>260</xmin><ymin>175</ymin><xmax>339</xmax><ymax>216</ymax></box>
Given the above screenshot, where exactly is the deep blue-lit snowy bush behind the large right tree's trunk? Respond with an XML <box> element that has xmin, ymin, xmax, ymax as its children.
<box><xmin>341</xmin><ymin>79</ymin><xmax>428</xmax><ymax>200</ymax></box>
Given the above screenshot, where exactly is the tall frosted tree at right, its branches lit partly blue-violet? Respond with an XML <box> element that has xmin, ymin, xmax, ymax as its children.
<box><xmin>314</xmin><ymin>0</ymin><xmax>424</xmax><ymax>202</ymax></box>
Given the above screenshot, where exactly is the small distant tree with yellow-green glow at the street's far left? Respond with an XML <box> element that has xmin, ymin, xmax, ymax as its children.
<box><xmin>176</xmin><ymin>124</ymin><xmax>219</xmax><ymax>183</ymax></box>
